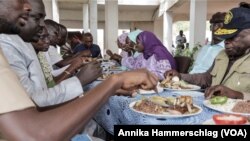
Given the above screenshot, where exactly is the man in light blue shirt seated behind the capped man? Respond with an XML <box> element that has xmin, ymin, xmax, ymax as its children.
<box><xmin>189</xmin><ymin>12</ymin><xmax>226</xmax><ymax>74</ymax></box>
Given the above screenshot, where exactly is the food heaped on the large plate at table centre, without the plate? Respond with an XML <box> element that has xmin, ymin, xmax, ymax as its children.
<box><xmin>133</xmin><ymin>96</ymin><xmax>199</xmax><ymax>115</ymax></box>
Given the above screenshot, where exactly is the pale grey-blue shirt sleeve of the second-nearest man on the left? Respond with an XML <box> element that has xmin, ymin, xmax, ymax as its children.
<box><xmin>0</xmin><ymin>34</ymin><xmax>83</xmax><ymax>107</ymax></box>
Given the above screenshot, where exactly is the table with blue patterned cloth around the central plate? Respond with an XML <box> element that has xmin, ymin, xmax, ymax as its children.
<box><xmin>95</xmin><ymin>91</ymin><xmax>221</xmax><ymax>134</ymax></box>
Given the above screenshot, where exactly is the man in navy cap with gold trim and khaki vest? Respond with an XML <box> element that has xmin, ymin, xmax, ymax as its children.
<box><xmin>165</xmin><ymin>7</ymin><xmax>250</xmax><ymax>99</ymax></box>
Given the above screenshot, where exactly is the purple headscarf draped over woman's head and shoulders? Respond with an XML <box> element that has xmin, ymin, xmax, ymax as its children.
<box><xmin>137</xmin><ymin>31</ymin><xmax>176</xmax><ymax>69</ymax></box>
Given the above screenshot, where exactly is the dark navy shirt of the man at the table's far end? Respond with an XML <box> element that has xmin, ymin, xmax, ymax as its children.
<box><xmin>73</xmin><ymin>44</ymin><xmax>102</xmax><ymax>58</ymax></box>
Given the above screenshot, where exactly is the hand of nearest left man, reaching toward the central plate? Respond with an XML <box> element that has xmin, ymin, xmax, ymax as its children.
<box><xmin>116</xmin><ymin>69</ymin><xmax>159</xmax><ymax>91</ymax></box>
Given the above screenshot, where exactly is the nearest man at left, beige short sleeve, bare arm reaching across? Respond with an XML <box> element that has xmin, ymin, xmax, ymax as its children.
<box><xmin>0</xmin><ymin>0</ymin><xmax>158</xmax><ymax>141</ymax></box>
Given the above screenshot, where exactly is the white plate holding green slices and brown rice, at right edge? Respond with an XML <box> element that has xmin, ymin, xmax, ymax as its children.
<box><xmin>203</xmin><ymin>98</ymin><xmax>250</xmax><ymax>116</ymax></box>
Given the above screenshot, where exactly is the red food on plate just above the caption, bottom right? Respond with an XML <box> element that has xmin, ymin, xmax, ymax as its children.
<box><xmin>213</xmin><ymin>114</ymin><xmax>247</xmax><ymax>125</ymax></box>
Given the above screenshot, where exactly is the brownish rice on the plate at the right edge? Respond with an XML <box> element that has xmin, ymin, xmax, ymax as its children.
<box><xmin>232</xmin><ymin>100</ymin><xmax>250</xmax><ymax>114</ymax></box>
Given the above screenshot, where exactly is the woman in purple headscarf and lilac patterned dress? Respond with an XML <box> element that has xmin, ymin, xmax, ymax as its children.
<box><xmin>123</xmin><ymin>31</ymin><xmax>176</xmax><ymax>80</ymax></box>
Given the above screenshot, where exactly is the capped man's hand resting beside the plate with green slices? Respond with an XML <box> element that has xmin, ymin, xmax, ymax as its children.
<box><xmin>205</xmin><ymin>85</ymin><xmax>243</xmax><ymax>99</ymax></box>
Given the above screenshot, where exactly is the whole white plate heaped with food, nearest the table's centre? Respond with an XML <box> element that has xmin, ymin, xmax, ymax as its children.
<box><xmin>129</xmin><ymin>96</ymin><xmax>202</xmax><ymax>118</ymax></box>
